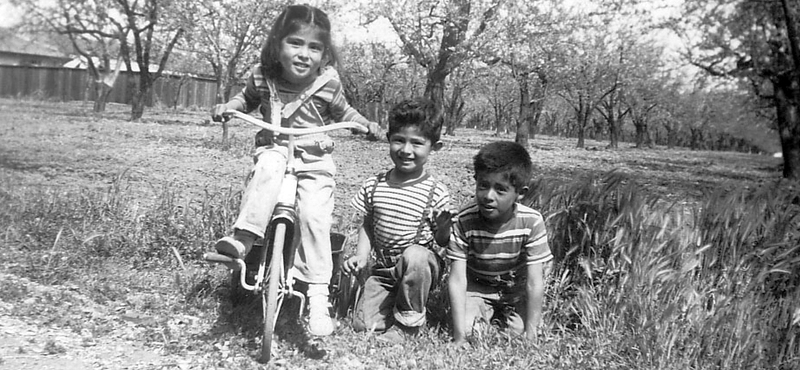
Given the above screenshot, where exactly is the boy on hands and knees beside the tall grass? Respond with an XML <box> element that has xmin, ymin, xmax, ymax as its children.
<box><xmin>447</xmin><ymin>141</ymin><xmax>553</xmax><ymax>344</ymax></box>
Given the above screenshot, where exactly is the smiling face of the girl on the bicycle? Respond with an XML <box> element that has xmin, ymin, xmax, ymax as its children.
<box><xmin>278</xmin><ymin>26</ymin><xmax>325</xmax><ymax>85</ymax></box>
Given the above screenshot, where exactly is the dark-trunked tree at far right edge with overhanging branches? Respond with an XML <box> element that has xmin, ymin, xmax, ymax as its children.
<box><xmin>673</xmin><ymin>0</ymin><xmax>800</xmax><ymax>179</ymax></box>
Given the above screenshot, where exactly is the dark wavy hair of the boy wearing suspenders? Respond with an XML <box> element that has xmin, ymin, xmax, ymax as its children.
<box><xmin>387</xmin><ymin>98</ymin><xmax>444</xmax><ymax>143</ymax></box>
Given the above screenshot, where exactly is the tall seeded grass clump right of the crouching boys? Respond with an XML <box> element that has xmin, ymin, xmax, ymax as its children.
<box><xmin>524</xmin><ymin>172</ymin><xmax>800</xmax><ymax>369</ymax></box>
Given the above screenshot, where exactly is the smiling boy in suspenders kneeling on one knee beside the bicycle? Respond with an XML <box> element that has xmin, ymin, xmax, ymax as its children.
<box><xmin>343</xmin><ymin>98</ymin><xmax>454</xmax><ymax>340</ymax></box>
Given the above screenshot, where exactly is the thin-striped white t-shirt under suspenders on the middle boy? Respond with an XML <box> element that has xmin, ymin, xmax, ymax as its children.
<box><xmin>351</xmin><ymin>173</ymin><xmax>450</xmax><ymax>258</ymax></box>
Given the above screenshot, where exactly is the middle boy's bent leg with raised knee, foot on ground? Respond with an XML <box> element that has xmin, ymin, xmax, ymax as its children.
<box><xmin>394</xmin><ymin>245</ymin><xmax>439</xmax><ymax>327</ymax></box>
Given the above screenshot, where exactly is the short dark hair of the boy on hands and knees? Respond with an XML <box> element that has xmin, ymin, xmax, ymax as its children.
<box><xmin>473</xmin><ymin>141</ymin><xmax>533</xmax><ymax>191</ymax></box>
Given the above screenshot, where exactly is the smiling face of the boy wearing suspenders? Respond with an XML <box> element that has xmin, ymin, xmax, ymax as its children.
<box><xmin>387</xmin><ymin>126</ymin><xmax>442</xmax><ymax>180</ymax></box>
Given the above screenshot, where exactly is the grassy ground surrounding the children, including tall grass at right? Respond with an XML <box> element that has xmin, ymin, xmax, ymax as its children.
<box><xmin>0</xmin><ymin>100</ymin><xmax>800</xmax><ymax>369</ymax></box>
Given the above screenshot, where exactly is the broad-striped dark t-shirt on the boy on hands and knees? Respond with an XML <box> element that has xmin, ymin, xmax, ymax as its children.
<box><xmin>447</xmin><ymin>201</ymin><xmax>553</xmax><ymax>287</ymax></box>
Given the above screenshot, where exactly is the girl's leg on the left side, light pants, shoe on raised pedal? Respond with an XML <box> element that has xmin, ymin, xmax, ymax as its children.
<box><xmin>216</xmin><ymin>147</ymin><xmax>286</xmax><ymax>258</ymax></box>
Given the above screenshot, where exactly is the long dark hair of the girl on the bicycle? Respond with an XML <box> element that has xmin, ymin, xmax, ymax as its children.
<box><xmin>261</xmin><ymin>4</ymin><xmax>339</xmax><ymax>78</ymax></box>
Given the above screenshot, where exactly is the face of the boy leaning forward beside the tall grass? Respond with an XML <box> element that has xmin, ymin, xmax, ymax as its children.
<box><xmin>475</xmin><ymin>173</ymin><xmax>524</xmax><ymax>224</ymax></box>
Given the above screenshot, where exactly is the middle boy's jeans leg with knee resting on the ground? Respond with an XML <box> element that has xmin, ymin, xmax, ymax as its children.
<box><xmin>353</xmin><ymin>268</ymin><xmax>397</xmax><ymax>332</ymax></box>
